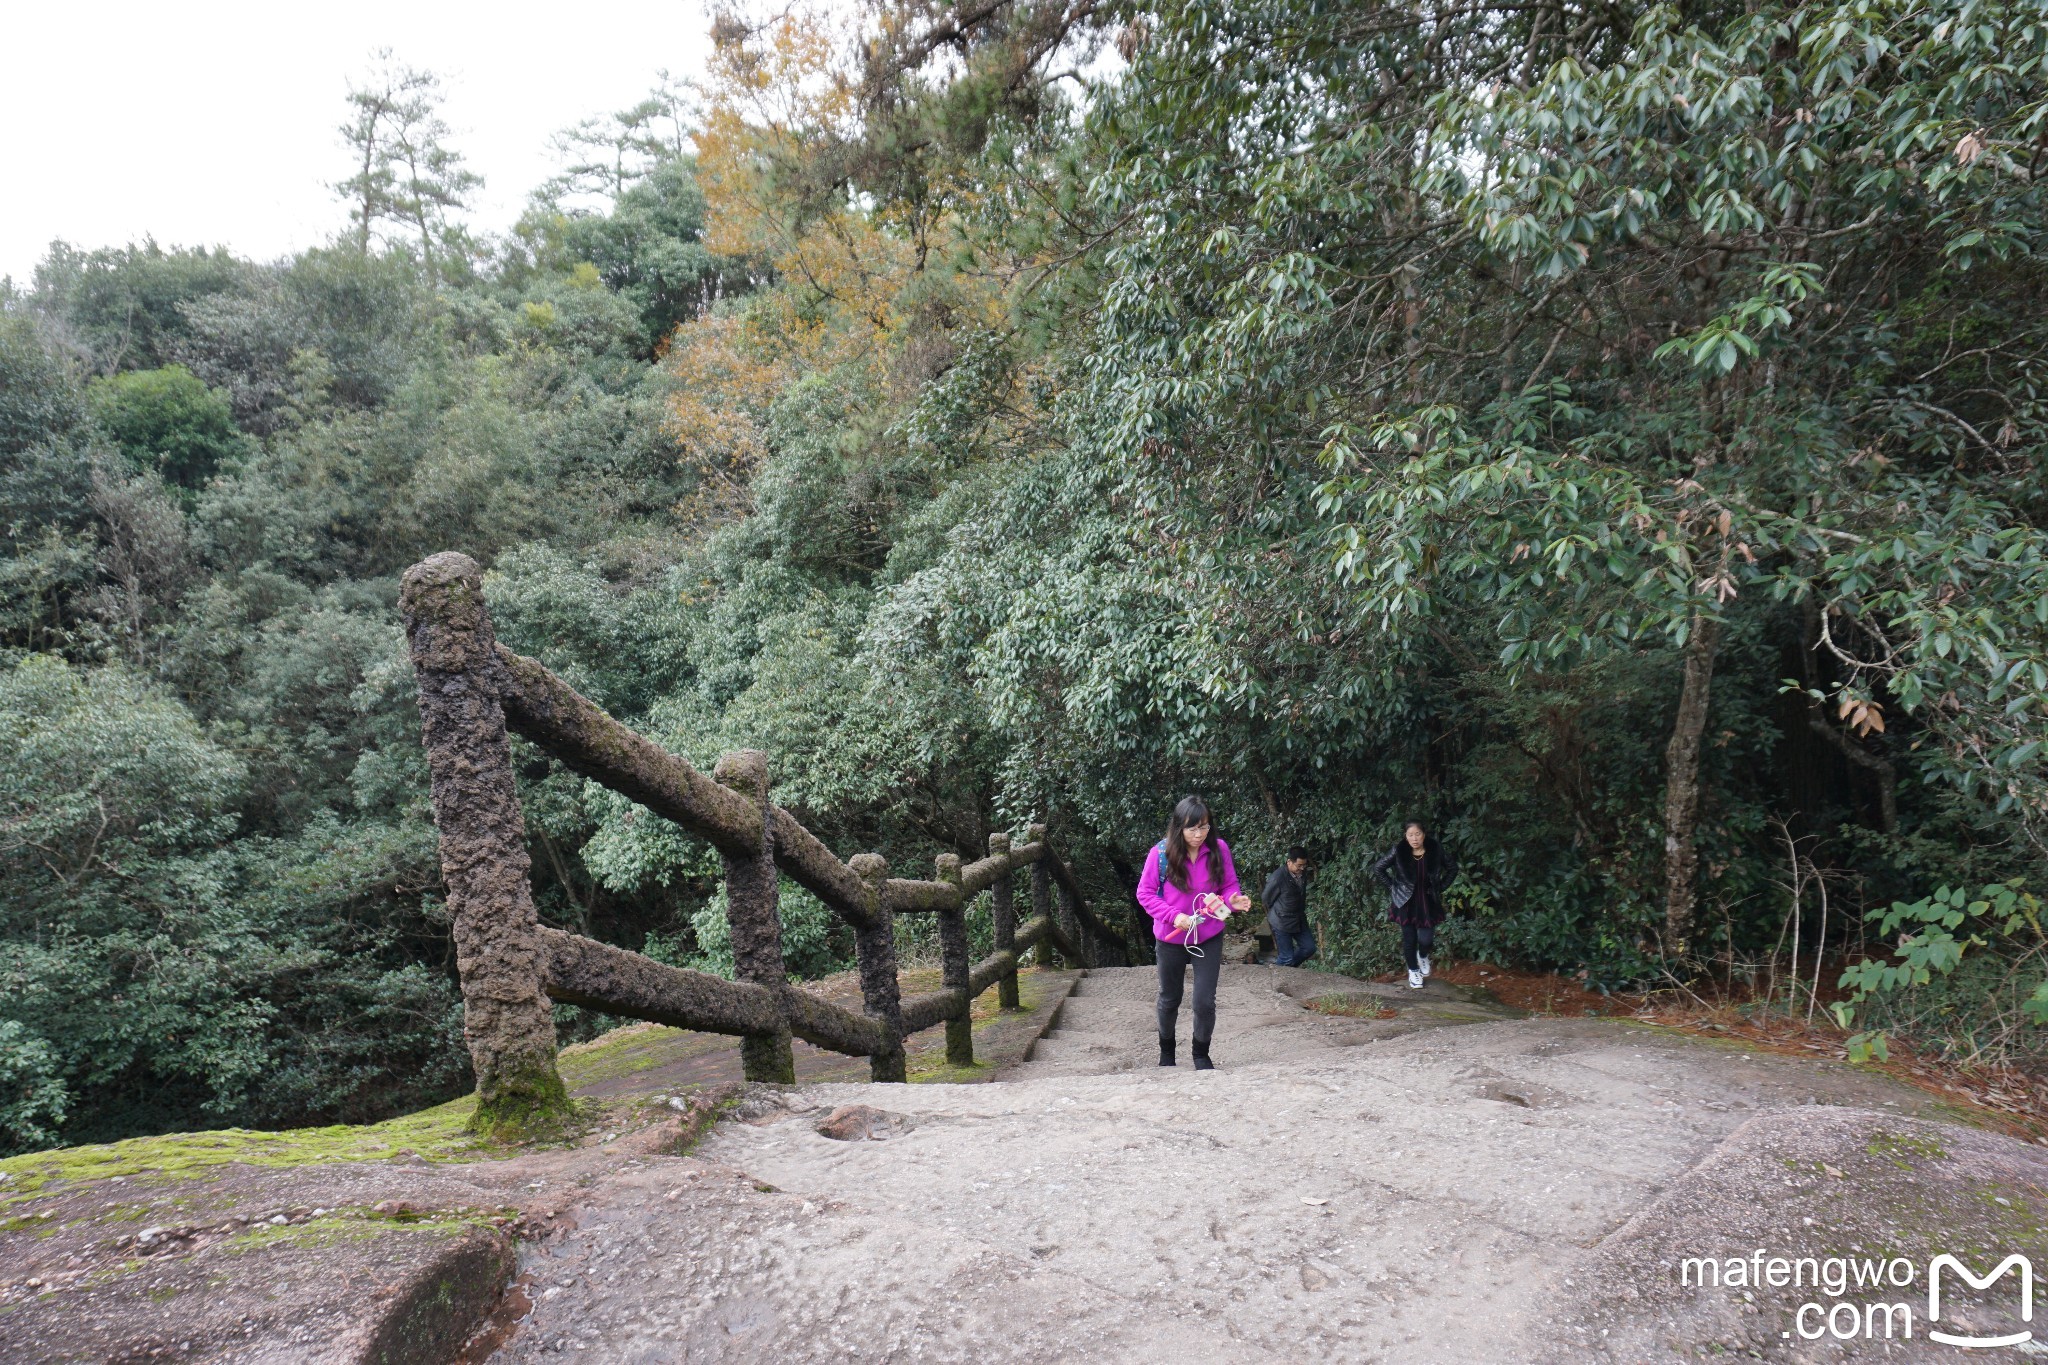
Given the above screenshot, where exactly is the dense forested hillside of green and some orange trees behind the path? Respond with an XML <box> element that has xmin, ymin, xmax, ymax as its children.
<box><xmin>0</xmin><ymin>0</ymin><xmax>2048</xmax><ymax>1148</ymax></box>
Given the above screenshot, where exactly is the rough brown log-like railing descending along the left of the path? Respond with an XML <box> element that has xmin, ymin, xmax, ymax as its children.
<box><xmin>399</xmin><ymin>553</ymin><xmax>1130</xmax><ymax>1130</ymax></box>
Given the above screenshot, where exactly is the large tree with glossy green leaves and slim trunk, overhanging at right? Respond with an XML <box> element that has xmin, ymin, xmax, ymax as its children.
<box><xmin>1092</xmin><ymin>0</ymin><xmax>2048</xmax><ymax>954</ymax></box>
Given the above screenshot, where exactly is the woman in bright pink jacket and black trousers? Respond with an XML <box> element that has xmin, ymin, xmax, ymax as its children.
<box><xmin>1137</xmin><ymin>796</ymin><xmax>1251</xmax><ymax>1070</ymax></box>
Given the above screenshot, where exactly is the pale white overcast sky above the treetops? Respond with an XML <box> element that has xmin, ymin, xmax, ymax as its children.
<box><xmin>0</xmin><ymin>0</ymin><xmax>711</xmax><ymax>282</ymax></box>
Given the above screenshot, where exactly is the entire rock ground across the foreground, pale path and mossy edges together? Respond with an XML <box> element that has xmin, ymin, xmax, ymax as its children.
<box><xmin>0</xmin><ymin>966</ymin><xmax>2048</xmax><ymax>1365</ymax></box>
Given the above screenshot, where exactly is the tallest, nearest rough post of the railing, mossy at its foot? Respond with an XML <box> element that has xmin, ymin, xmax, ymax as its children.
<box><xmin>399</xmin><ymin>553</ymin><xmax>571</xmax><ymax>1136</ymax></box>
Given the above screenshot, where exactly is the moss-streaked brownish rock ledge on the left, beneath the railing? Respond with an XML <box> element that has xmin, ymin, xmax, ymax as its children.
<box><xmin>0</xmin><ymin>972</ymin><xmax>1077</xmax><ymax>1365</ymax></box>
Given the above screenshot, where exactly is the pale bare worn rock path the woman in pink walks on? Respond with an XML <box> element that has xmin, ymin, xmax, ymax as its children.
<box><xmin>494</xmin><ymin>966</ymin><xmax>2007</xmax><ymax>1365</ymax></box>
